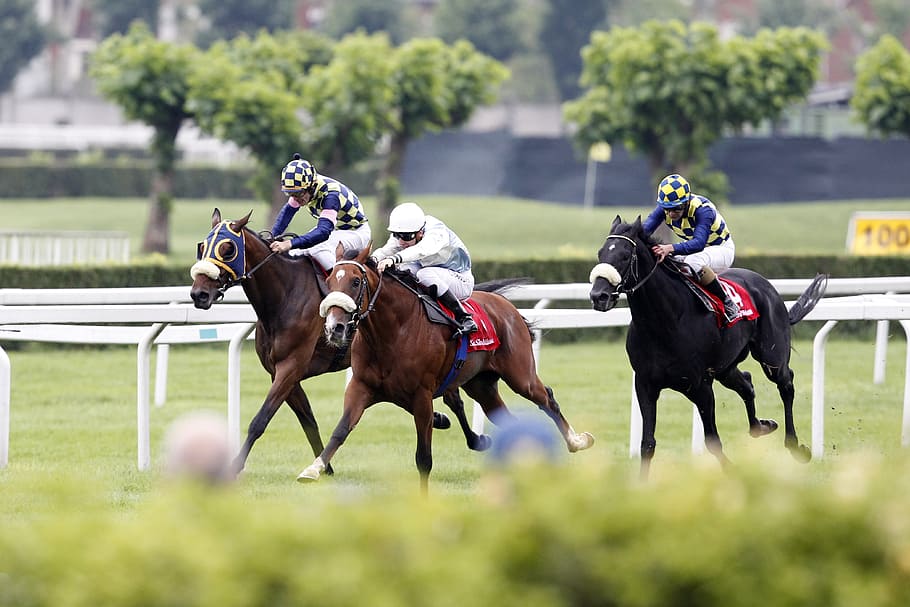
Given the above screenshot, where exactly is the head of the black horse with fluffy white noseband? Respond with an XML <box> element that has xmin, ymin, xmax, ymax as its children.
<box><xmin>590</xmin><ymin>215</ymin><xmax>644</xmax><ymax>312</ymax></box>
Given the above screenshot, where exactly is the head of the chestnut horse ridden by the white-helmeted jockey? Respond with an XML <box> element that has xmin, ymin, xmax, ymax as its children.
<box><xmin>319</xmin><ymin>243</ymin><xmax>379</xmax><ymax>347</ymax></box>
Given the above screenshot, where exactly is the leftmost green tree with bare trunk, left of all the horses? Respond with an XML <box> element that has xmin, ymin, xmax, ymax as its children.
<box><xmin>90</xmin><ymin>21</ymin><xmax>199</xmax><ymax>254</ymax></box>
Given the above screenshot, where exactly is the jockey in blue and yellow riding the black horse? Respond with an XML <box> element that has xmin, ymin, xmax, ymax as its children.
<box><xmin>642</xmin><ymin>173</ymin><xmax>739</xmax><ymax>320</ymax></box>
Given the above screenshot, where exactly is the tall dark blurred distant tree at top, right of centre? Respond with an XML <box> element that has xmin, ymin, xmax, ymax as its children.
<box><xmin>539</xmin><ymin>0</ymin><xmax>615</xmax><ymax>101</ymax></box>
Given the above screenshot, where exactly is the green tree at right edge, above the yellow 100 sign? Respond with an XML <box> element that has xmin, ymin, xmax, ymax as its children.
<box><xmin>850</xmin><ymin>35</ymin><xmax>910</xmax><ymax>137</ymax></box>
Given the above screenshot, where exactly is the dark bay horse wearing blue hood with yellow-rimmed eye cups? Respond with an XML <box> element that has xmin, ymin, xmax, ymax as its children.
<box><xmin>190</xmin><ymin>208</ymin><xmax>464</xmax><ymax>474</ymax></box>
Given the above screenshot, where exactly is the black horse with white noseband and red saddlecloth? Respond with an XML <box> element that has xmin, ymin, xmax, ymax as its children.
<box><xmin>591</xmin><ymin>216</ymin><xmax>828</xmax><ymax>478</ymax></box>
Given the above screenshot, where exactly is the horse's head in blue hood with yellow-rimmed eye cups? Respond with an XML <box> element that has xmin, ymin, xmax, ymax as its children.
<box><xmin>190</xmin><ymin>208</ymin><xmax>253</xmax><ymax>310</ymax></box>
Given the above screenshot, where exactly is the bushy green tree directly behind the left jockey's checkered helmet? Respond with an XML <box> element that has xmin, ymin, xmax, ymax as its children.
<box><xmin>189</xmin><ymin>31</ymin><xmax>332</xmax><ymax>217</ymax></box>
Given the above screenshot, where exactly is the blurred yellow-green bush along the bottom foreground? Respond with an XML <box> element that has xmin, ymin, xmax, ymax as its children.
<box><xmin>0</xmin><ymin>460</ymin><xmax>910</xmax><ymax>607</ymax></box>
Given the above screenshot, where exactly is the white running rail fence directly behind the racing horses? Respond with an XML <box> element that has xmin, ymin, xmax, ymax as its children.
<box><xmin>0</xmin><ymin>277</ymin><xmax>910</xmax><ymax>470</ymax></box>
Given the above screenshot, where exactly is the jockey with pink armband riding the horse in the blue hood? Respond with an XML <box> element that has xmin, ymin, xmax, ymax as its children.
<box><xmin>270</xmin><ymin>154</ymin><xmax>371</xmax><ymax>271</ymax></box>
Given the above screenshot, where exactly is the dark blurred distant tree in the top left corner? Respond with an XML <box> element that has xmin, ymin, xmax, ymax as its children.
<box><xmin>0</xmin><ymin>0</ymin><xmax>50</xmax><ymax>93</ymax></box>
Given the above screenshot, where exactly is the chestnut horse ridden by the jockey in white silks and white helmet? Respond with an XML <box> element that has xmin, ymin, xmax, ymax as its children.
<box><xmin>298</xmin><ymin>248</ymin><xmax>594</xmax><ymax>492</ymax></box>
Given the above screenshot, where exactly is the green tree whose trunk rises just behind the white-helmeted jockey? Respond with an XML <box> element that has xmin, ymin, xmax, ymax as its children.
<box><xmin>377</xmin><ymin>38</ymin><xmax>508</xmax><ymax>220</ymax></box>
